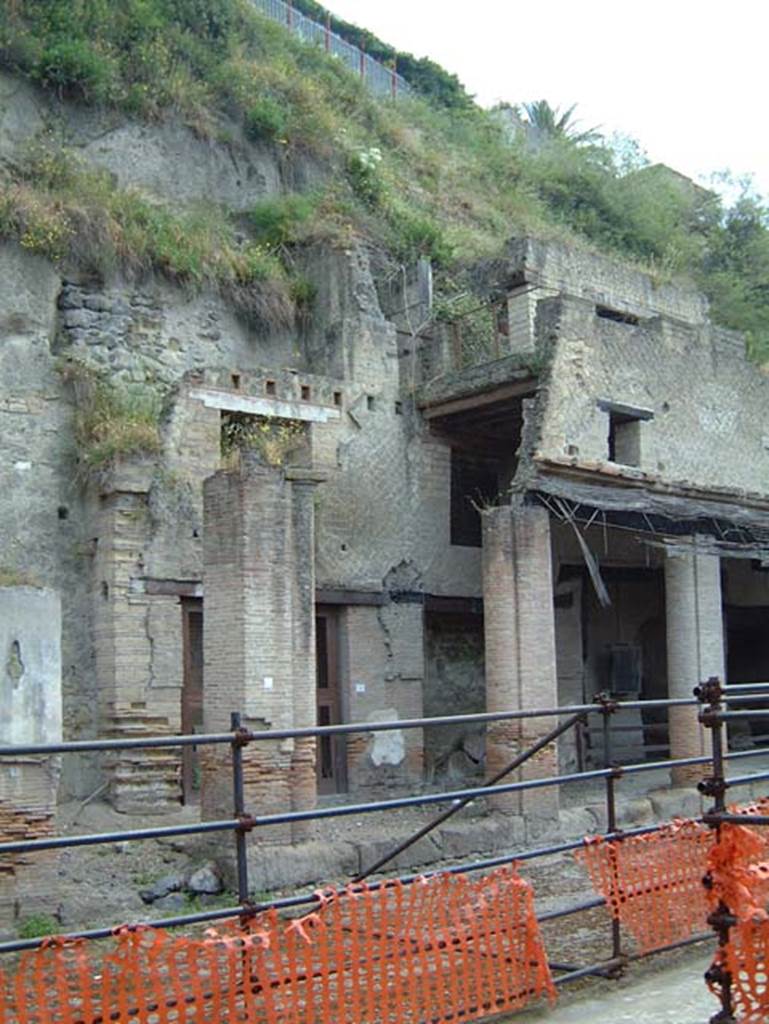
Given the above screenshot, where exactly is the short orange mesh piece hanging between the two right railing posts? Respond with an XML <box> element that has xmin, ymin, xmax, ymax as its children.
<box><xmin>575</xmin><ymin>821</ymin><xmax>714</xmax><ymax>952</ymax></box>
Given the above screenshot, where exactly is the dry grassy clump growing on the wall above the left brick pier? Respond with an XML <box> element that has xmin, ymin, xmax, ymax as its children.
<box><xmin>60</xmin><ymin>360</ymin><xmax>163</xmax><ymax>471</ymax></box>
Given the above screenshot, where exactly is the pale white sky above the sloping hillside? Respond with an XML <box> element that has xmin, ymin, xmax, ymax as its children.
<box><xmin>327</xmin><ymin>0</ymin><xmax>769</xmax><ymax>197</ymax></box>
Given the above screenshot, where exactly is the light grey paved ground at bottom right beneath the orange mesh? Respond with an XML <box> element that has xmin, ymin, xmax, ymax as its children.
<box><xmin>506</xmin><ymin>951</ymin><xmax>719</xmax><ymax>1024</ymax></box>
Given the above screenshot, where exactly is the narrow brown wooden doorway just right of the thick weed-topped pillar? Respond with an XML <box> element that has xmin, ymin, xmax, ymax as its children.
<box><xmin>315</xmin><ymin>605</ymin><xmax>347</xmax><ymax>794</ymax></box>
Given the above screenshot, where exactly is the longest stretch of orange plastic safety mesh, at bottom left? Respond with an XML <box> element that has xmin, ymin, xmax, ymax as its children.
<box><xmin>0</xmin><ymin>867</ymin><xmax>555</xmax><ymax>1024</ymax></box>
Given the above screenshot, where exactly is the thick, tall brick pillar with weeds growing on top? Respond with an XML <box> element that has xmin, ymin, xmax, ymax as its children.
<box><xmin>201</xmin><ymin>456</ymin><xmax>315</xmax><ymax>841</ymax></box>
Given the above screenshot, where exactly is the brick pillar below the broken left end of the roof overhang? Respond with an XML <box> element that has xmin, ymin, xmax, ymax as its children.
<box><xmin>483</xmin><ymin>507</ymin><xmax>558</xmax><ymax>833</ymax></box>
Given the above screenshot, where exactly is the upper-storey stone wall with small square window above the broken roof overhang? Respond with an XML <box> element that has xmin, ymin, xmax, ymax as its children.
<box><xmin>536</xmin><ymin>299</ymin><xmax>769</xmax><ymax>499</ymax></box>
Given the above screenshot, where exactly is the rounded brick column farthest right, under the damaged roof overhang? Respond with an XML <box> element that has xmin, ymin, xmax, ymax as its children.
<box><xmin>665</xmin><ymin>538</ymin><xmax>725</xmax><ymax>785</ymax></box>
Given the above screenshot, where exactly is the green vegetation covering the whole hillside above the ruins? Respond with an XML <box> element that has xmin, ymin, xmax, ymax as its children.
<box><xmin>0</xmin><ymin>0</ymin><xmax>769</xmax><ymax>359</ymax></box>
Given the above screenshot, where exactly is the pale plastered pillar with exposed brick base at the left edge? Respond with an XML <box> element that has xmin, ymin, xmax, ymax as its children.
<box><xmin>0</xmin><ymin>587</ymin><xmax>61</xmax><ymax>937</ymax></box>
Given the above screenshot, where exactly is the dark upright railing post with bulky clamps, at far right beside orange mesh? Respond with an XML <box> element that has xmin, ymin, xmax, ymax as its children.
<box><xmin>694</xmin><ymin>676</ymin><xmax>736</xmax><ymax>1024</ymax></box>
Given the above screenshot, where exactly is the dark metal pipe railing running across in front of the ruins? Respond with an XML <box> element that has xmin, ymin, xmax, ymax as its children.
<box><xmin>0</xmin><ymin>687</ymin><xmax>769</xmax><ymax>1007</ymax></box>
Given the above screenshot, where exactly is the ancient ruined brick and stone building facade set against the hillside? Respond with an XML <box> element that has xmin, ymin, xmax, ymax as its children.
<box><xmin>0</xmin><ymin>70</ymin><xmax>769</xmax><ymax>847</ymax></box>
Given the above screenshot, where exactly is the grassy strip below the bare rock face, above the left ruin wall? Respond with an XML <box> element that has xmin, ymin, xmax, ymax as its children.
<box><xmin>0</xmin><ymin>136</ymin><xmax>294</xmax><ymax>327</ymax></box>
